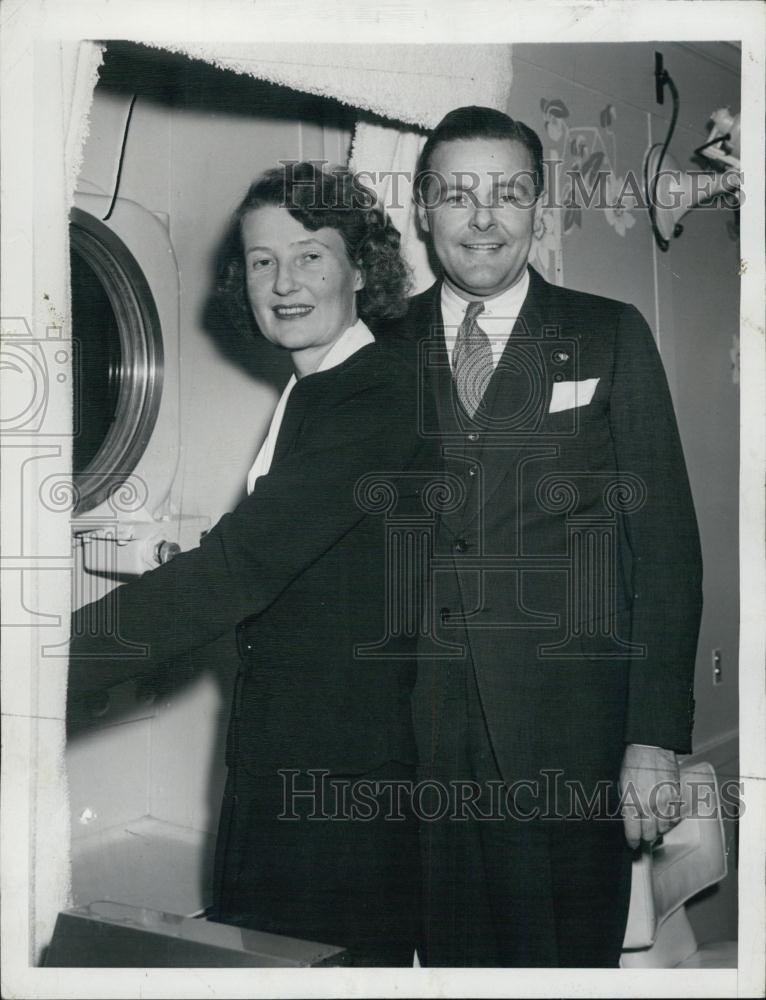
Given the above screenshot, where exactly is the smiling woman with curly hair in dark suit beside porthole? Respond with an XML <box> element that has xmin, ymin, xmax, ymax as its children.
<box><xmin>70</xmin><ymin>164</ymin><xmax>435</xmax><ymax>965</ymax></box>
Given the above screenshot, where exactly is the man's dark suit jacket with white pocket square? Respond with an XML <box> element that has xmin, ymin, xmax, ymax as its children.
<box><xmin>388</xmin><ymin>268</ymin><xmax>701</xmax><ymax>792</ymax></box>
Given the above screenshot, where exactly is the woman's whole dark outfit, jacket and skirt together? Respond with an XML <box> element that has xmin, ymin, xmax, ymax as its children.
<box><xmin>70</xmin><ymin>343</ymin><xmax>444</xmax><ymax>965</ymax></box>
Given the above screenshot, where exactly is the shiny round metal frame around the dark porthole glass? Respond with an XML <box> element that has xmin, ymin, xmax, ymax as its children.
<box><xmin>69</xmin><ymin>208</ymin><xmax>164</xmax><ymax>514</ymax></box>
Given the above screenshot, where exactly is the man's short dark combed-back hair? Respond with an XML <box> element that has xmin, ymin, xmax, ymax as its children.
<box><xmin>413</xmin><ymin>105</ymin><xmax>545</xmax><ymax>204</ymax></box>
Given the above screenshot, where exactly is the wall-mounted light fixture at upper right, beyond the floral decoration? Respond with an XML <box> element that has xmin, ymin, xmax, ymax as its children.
<box><xmin>644</xmin><ymin>52</ymin><xmax>741</xmax><ymax>251</ymax></box>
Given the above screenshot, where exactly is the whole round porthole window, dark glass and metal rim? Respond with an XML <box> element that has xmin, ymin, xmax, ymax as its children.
<box><xmin>69</xmin><ymin>209</ymin><xmax>162</xmax><ymax>514</ymax></box>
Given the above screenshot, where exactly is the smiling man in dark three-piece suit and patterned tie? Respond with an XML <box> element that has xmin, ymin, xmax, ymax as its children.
<box><xmin>388</xmin><ymin>107</ymin><xmax>701</xmax><ymax>967</ymax></box>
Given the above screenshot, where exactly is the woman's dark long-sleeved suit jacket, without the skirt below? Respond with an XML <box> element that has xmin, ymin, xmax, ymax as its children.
<box><xmin>70</xmin><ymin>342</ymin><xmax>444</xmax><ymax>775</ymax></box>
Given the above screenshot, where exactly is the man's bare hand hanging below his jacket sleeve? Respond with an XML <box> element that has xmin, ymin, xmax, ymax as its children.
<box><xmin>620</xmin><ymin>743</ymin><xmax>681</xmax><ymax>848</ymax></box>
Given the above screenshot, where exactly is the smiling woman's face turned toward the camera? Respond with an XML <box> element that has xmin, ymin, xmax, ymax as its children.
<box><xmin>242</xmin><ymin>205</ymin><xmax>364</xmax><ymax>376</ymax></box>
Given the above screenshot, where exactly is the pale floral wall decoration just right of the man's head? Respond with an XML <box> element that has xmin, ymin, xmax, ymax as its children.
<box><xmin>532</xmin><ymin>97</ymin><xmax>643</xmax><ymax>281</ymax></box>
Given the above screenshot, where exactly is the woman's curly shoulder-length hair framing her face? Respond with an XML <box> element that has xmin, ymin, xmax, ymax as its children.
<box><xmin>218</xmin><ymin>161</ymin><xmax>411</xmax><ymax>331</ymax></box>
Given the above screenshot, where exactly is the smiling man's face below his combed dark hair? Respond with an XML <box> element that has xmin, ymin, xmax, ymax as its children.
<box><xmin>418</xmin><ymin>139</ymin><xmax>541</xmax><ymax>299</ymax></box>
